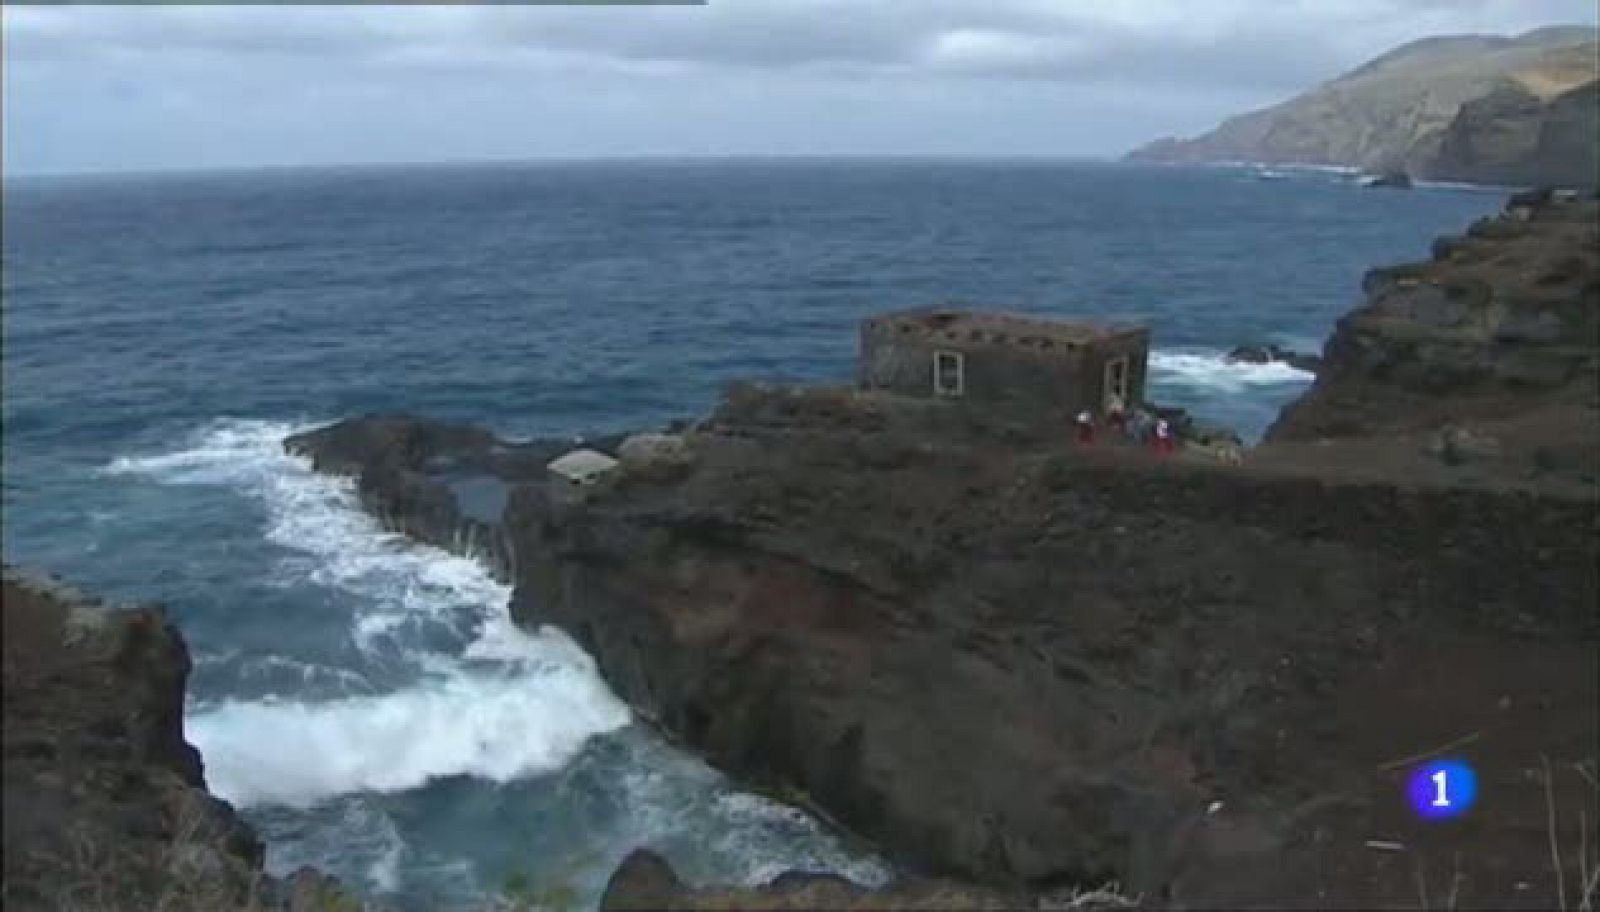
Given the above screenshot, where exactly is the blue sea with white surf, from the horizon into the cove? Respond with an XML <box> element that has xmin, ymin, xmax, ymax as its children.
<box><xmin>3</xmin><ymin>160</ymin><xmax>1501</xmax><ymax>909</ymax></box>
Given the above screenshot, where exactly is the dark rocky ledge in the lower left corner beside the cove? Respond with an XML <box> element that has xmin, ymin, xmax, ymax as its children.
<box><xmin>3</xmin><ymin>566</ymin><xmax>362</xmax><ymax>912</ymax></box>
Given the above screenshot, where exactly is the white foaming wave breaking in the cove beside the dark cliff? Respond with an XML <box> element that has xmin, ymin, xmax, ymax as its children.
<box><xmin>106</xmin><ymin>421</ymin><xmax>630</xmax><ymax>806</ymax></box>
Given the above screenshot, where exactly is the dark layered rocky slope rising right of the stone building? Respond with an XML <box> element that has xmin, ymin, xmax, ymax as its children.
<box><xmin>1267</xmin><ymin>194</ymin><xmax>1600</xmax><ymax>483</ymax></box>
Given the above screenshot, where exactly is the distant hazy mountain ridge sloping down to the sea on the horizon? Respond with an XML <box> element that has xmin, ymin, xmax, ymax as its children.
<box><xmin>1128</xmin><ymin>26</ymin><xmax>1600</xmax><ymax>186</ymax></box>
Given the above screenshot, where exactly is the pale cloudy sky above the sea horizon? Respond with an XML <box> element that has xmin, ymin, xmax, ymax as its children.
<box><xmin>0</xmin><ymin>0</ymin><xmax>1595</xmax><ymax>174</ymax></box>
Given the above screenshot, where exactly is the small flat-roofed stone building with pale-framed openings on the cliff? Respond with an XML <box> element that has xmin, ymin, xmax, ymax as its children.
<box><xmin>861</xmin><ymin>307</ymin><xmax>1150</xmax><ymax>416</ymax></box>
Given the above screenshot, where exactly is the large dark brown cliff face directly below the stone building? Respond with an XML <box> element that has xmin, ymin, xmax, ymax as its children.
<box><xmin>298</xmin><ymin>412</ymin><xmax>1600</xmax><ymax>907</ymax></box>
